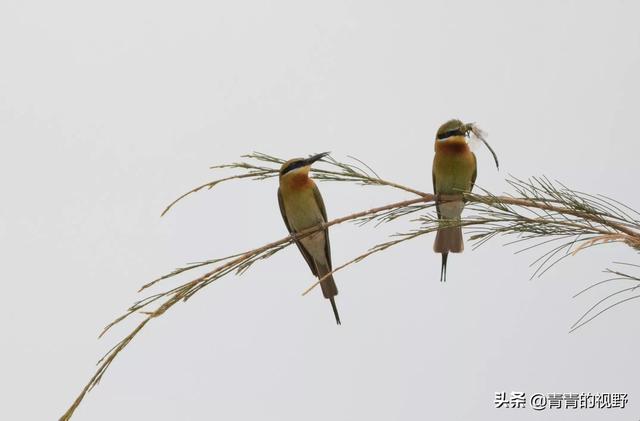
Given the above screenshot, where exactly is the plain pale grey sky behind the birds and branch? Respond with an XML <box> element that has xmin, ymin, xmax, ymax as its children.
<box><xmin>0</xmin><ymin>0</ymin><xmax>640</xmax><ymax>421</ymax></box>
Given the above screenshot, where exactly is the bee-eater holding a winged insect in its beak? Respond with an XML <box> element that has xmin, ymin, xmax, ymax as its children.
<box><xmin>432</xmin><ymin>119</ymin><xmax>498</xmax><ymax>282</ymax></box>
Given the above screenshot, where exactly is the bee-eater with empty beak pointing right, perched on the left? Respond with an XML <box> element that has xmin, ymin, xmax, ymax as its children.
<box><xmin>278</xmin><ymin>152</ymin><xmax>340</xmax><ymax>324</ymax></box>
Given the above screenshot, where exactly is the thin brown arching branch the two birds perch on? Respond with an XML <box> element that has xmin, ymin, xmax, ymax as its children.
<box><xmin>60</xmin><ymin>154</ymin><xmax>640</xmax><ymax>421</ymax></box>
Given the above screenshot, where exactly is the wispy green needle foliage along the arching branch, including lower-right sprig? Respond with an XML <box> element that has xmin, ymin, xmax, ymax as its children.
<box><xmin>60</xmin><ymin>152</ymin><xmax>640</xmax><ymax>420</ymax></box>
